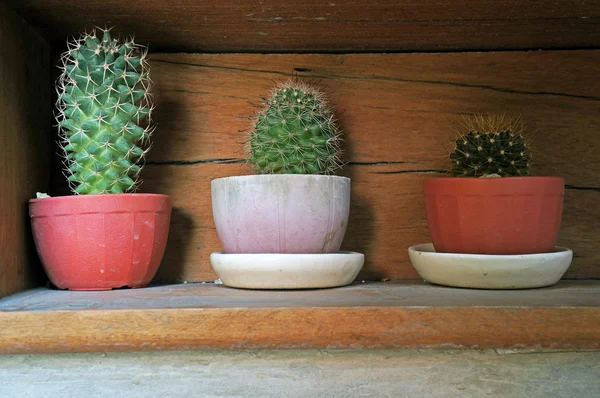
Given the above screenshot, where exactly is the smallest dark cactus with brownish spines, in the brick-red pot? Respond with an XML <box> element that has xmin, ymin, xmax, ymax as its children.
<box><xmin>450</xmin><ymin>115</ymin><xmax>531</xmax><ymax>177</ymax></box>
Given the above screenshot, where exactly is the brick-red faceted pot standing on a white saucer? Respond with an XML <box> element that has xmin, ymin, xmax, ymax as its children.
<box><xmin>424</xmin><ymin>177</ymin><xmax>564</xmax><ymax>254</ymax></box>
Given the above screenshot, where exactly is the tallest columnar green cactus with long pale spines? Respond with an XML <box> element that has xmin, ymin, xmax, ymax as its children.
<box><xmin>56</xmin><ymin>30</ymin><xmax>153</xmax><ymax>194</ymax></box>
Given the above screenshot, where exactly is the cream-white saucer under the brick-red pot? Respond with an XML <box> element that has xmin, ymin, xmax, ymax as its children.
<box><xmin>408</xmin><ymin>243</ymin><xmax>573</xmax><ymax>289</ymax></box>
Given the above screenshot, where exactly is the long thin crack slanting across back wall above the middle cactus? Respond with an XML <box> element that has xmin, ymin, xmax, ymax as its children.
<box><xmin>152</xmin><ymin>59</ymin><xmax>600</xmax><ymax>101</ymax></box>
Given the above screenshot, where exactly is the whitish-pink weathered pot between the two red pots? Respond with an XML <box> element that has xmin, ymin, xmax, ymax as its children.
<box><xmin>212</xmin><ymin>174</ymin><xmax>350</xmax><ymax>254</ymax></box>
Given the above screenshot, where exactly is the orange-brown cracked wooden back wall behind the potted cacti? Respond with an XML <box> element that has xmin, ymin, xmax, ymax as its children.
<box><xmin>88</xmin><ymin>51</ymin><xmax>600</xmax><ymax>282</ymax></box>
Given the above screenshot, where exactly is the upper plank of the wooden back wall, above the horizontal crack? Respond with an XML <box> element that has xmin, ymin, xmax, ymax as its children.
<box><xmin>142</xmin><ymin>51</ymin><xmax>600</xmax><ymax>187</ymax></box>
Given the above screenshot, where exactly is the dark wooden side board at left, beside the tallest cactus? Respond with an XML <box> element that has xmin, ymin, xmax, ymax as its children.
<box><xmin>0</xmin><ymin>4</ymin><xmax>51</xmax><ymax>297</ymax></box>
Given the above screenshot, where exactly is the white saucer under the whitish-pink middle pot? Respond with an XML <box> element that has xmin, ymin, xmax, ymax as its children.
<box><xmin>210</xmin><ymin>252</ymin><xmax>365</xmax><ymax>289</ymax></box>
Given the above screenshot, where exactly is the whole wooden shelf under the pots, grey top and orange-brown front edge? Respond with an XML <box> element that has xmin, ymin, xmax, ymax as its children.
<box><xmin>0</xmin><ymin>281</ymin><xmax>600</xmax><ymax>354</ymax></box>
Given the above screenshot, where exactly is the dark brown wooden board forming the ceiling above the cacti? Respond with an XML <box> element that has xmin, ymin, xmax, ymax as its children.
<box><xmin>4</xmin><ymin>0</ymin><xmax>600</xmax><ymax>52</ymax></box>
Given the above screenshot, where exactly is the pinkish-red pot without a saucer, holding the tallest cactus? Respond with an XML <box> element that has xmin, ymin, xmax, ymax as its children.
<box><xmin>29</xmin><ymin>194</ymin><xmax>171</xmax><ymax>290</ymax></box>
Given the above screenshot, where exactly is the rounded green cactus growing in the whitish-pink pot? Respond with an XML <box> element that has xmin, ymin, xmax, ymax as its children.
<box><xmin>248</xmin><ymin>79</ymin><xmax>342</xmax><ymax>174</ymax></box>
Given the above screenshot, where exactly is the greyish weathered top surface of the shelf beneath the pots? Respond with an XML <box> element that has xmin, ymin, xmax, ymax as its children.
<box><xmin>0</xmin><ymin>280</ymin><xmax>600</xmax><ymax>312</ymax></box>
